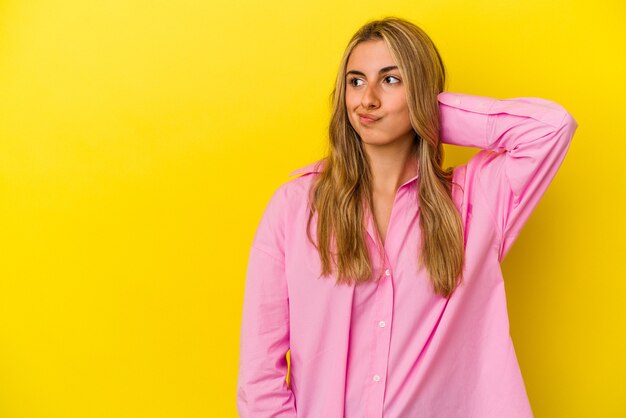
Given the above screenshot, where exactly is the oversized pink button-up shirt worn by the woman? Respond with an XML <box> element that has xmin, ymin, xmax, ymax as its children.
<box><xmin>237</xmin><ymin>92</ymin><xmax>578</xmax><ymax>418</ymax></box>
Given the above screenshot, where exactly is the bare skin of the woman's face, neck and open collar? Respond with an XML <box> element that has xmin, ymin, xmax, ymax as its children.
<box><xmin>346</xmin><ymin>40</ymin><xmax>417</xmax><ymax>242</ymax></box>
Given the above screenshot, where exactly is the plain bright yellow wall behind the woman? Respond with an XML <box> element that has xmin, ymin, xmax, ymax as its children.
<box><xmin>0</xmin><ymin>0</ymin><xmax>626</xmax><ymax>418</ymax></box>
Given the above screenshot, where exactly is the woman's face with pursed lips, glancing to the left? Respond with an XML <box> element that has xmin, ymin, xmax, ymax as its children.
<box><xmin>346</xmin><ymin>40</ymin><xmax>414</xmax><ymax>145</ymax></box>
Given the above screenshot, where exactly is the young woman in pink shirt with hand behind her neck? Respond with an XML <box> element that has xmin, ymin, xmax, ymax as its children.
<box><xmin>237</xmin><ymin>17</ymin><xmax>577</xmax><ymax>418</ymax></box>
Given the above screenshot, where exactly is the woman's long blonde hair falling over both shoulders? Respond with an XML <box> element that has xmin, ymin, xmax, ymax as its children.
<box><xmin>307</xmin><ymin>17</ymin><xmax>465</xmax><ymax>297</ymax></box>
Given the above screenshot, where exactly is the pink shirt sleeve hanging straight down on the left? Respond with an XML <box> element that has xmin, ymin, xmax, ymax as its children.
<box><xmin>237</xmin><ymin>187</ymin><xmax>296</xmax><ymax>418</ymax></box>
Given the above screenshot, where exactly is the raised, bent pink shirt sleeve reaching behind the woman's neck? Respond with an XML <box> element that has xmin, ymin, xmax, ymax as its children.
<box><xmin>438</xmin><ymin>92</ymin><xmax>578</xmax><ymax>262</ymax></box>
